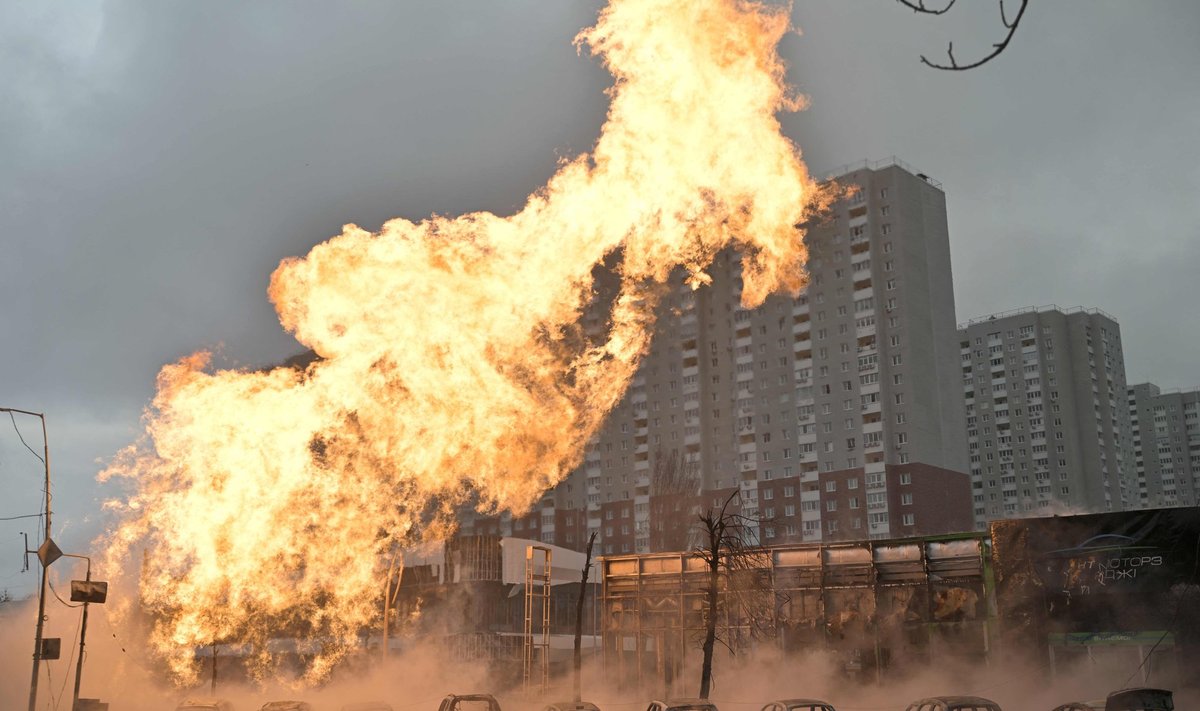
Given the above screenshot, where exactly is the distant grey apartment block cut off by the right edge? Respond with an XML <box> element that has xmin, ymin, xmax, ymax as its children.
<box><xmin>1129</xmin><ymin>383</ymin><xmax>1200</xmax><ymax>508</ymax></box>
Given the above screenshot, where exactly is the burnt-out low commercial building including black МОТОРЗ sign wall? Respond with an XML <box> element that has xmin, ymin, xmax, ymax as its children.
<box><xmin>601</xmin><ymin>508</ymin><xmax>1200</xmax><ymax>692</ymax></box>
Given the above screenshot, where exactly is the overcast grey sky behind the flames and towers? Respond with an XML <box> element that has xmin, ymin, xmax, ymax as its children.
<box><xmin>0</xmin><ymin>0</ymin><xmax>1200</xmax><ymax>592</ymax></box>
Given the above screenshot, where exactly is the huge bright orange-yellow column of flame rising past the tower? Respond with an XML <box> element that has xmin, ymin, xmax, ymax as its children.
<box><xmin>102</xmin><ymin>0</ymin><xmax>817</xmax><ymax>682</ymax></box>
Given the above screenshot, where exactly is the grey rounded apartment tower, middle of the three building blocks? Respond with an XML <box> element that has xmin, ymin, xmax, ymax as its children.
<box><xmin>959</xmin><ymin>306</ymin><xmax>1138</xmax><ymax>528</ymax></box>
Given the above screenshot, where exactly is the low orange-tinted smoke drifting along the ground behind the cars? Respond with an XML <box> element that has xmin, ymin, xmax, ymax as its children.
<box><xmin>0</xmin><ymin>598</ymin><xmax>1200</xmax><ymax>711</ymax></box>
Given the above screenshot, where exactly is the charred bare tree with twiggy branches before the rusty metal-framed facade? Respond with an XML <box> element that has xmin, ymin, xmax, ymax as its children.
<box><xmin>694</xmin><ymin>490</ymin><xmax>774</xmax><ymax>699</ymax></box>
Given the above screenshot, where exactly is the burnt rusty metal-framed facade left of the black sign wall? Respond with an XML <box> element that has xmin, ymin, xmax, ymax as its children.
<box><xmin>602</xmin><ymin>534</ymin><xmax>996</xmax><ymax>692</ymax></box>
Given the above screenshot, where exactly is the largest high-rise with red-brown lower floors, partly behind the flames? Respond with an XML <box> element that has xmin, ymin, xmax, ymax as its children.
<box><xmin>470</xmin><ymin>161</ymin><xmax>972</xmax><ymax>554</ymax></box>
